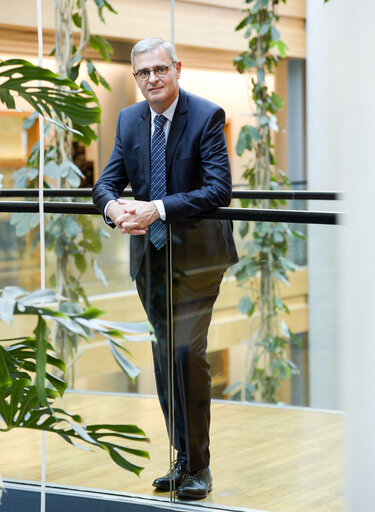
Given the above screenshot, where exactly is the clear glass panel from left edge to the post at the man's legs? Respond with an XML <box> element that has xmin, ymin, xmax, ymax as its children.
<box><xmin>0</xmin><ymin>210</ymin><xmax>169</xmax><ymax>502</ymax></box>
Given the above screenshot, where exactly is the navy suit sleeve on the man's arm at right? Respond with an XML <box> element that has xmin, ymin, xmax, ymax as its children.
<box><xmin>163</xmin><ymin>107</ymin><xmax>232</xmax><ymax>222</ymax></box>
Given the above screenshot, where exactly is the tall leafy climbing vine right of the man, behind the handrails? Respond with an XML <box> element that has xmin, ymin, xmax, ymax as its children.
<box><xmin>227</xmin><ymin>0</ymin><xmax>303</xmax><ymax>403</ymax></box>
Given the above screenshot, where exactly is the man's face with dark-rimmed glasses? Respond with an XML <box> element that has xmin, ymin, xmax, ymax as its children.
<box><xmin>134</xmin><ymin>46</ymin><xmax>181</xmax><ymax>114</ymax></box>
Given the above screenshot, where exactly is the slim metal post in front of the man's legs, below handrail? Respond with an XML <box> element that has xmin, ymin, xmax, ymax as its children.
<box><xmin>165</xmin><ymin>225</ymin><xmax>176</xmax><ymax>501</ymax></box>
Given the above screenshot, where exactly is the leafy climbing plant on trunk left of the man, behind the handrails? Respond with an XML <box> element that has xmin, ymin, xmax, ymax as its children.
<box><xmin>12</xmin><ymin>0</ymin><xmax>116</xmax><ymax>386</ymax></box>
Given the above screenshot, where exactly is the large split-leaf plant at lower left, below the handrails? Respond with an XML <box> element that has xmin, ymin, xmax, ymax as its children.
<box><xmin>0</xmin><ymin>286</ymin><xmax>153</xmax><ymax>475</ymax></box>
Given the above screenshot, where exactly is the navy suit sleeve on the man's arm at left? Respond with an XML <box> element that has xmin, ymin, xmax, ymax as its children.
<box><xmin>92</xmin><ymin>113</ymin><xmax>129</xmax><ymax>216</ymax></box>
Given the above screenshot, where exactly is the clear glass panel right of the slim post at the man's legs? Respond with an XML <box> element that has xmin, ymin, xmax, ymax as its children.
<box><xmin>169</xmin><ymin>221</ymin><xmax>344</xmax><ymax>512</ymax></box>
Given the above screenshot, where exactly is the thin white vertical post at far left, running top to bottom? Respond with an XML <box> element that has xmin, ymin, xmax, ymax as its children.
<box><xmin>36</xmin><ymin>0</ymin><xmax>47</xmax><ymax>512</ymax></box>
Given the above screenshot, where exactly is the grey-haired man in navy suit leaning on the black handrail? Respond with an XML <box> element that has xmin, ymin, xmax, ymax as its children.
<box><xmin>93</xmin><ymin>38</ymin><xmax>237</xmax><ymax>499</ymax></box>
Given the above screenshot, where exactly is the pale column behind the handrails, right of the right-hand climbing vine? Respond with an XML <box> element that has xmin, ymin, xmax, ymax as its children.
<box><xmin>306</xmin><ymin>0</ymin><xmax>343</xmax><ymax>409</ymax></box>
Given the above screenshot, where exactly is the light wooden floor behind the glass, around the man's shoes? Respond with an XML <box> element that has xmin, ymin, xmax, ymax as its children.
<box><xmin>0</xmin><ymin>393</ymin><xmax>345</xmax><ymax>512</ymax></box>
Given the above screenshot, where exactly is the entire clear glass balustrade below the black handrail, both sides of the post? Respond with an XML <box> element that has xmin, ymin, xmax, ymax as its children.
<box><xmin>0</xmin><ymin>208</ymin><xmax>344</xmax><ymax>512</ymax></box>
